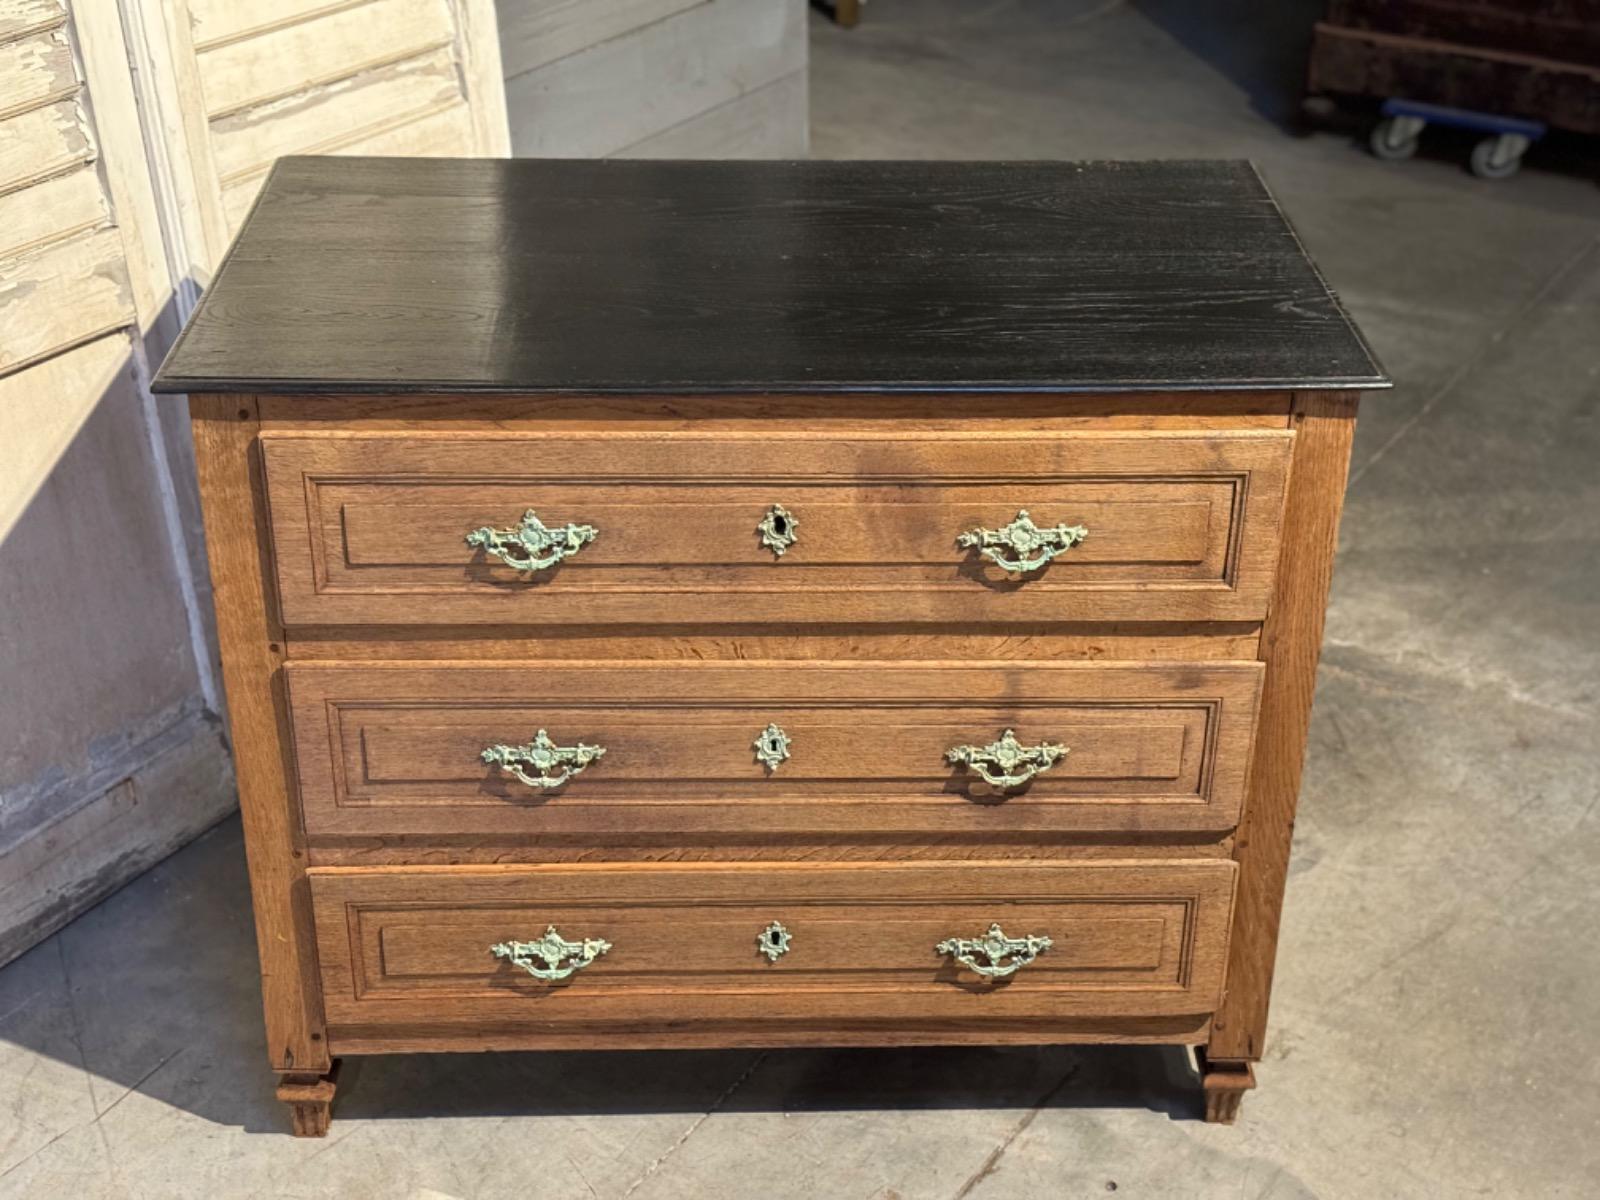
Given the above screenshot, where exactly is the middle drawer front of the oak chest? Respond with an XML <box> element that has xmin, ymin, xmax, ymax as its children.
<box><xmin>286</xmin><ymin>662</ymin><xmax>1261</xmax><ymax>840</ymax></box>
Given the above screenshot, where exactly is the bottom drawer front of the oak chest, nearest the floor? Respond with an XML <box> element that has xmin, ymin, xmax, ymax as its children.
<box><xmin>310</xmin><ymin>859</ymin><xmax>1235</xmax><ymax>1048</ymax></box>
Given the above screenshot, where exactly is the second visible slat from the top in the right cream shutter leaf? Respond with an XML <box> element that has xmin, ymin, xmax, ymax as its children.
<box><xmin>197</xmin><ymin>0</ymin><xmax>456</xmax><ymax>118</ymax></box>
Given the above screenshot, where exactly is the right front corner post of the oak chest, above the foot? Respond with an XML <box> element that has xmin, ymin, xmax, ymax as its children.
<box><xmin>1206</xmin><ymin>392</ymin><xmax>1357</xmax><ymax>1061</ymax></box>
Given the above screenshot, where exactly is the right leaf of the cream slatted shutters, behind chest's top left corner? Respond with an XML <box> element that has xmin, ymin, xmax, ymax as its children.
<box><xmin>143</xmin><ymin>0</ymin><xmax>510</xmax><ymax>267</ymax></box>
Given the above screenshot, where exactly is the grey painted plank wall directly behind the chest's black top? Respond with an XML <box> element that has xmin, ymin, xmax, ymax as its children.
<box><xmin>496</xmin><ymin>0</ymin><xmax>808</xmax><ymax>158</ymax></box>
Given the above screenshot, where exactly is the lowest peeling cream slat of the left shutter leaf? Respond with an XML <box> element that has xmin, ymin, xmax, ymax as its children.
<box><xmin>0</xmin><ymin>229</ymin><xmax>134</xmax><ymax>371</ymax></box>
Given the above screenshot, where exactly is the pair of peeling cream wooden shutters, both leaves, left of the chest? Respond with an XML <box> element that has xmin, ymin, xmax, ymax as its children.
<box><xmin>0</xmin><ymin>0</ymin><xmax>507</xmax><ymax>963</ymax></box>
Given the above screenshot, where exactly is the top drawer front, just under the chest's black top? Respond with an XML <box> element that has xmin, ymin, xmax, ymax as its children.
<box><xmin>261</xmin><ymin>430</ymin><xmax>1294</xmax><ymax>626</ymax></box>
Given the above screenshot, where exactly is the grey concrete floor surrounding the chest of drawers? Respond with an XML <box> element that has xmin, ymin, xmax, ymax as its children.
<box><xmin>0</xmin><ymin>0</ymin><xmax>1600</xmax><ymax>1200</ymax></box>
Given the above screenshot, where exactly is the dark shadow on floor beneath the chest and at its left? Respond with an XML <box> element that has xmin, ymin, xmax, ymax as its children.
<box><xmin>0</xmin><ymin>816</ymin><xmax>1202</xmax><ymax>1131</ymax></box>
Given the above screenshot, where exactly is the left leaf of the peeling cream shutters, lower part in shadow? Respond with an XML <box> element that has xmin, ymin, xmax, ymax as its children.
<box><xmin>0</xmin><ymin>0</ymin><xmax>232</xmax><ymax>962</ymax></box>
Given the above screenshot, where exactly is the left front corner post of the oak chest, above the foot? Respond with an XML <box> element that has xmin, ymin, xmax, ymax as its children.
<box><xmin>189</xmin><ymin>395</ymin><xmax>330</xmax><ymax>1072</ymax></box>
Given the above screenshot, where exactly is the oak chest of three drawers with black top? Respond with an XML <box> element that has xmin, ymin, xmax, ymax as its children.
<box><xmin>158</xmin><ymin>158</ymin><xmax>1387</xmax><ymax>1134</ymax></box>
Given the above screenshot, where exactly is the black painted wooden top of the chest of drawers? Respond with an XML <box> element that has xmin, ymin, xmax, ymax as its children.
<box><xmin>155</xmin><ymin>157</ymin><xmax>1387</xmax><ymax>394</ymax></box>
